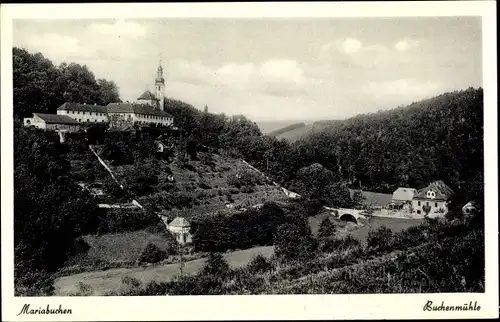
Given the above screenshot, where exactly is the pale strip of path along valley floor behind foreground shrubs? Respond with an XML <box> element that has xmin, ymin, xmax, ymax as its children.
<box><xmin>54</xmin><ymin>246</ymin><xmax>274</xmax><ymax>296</ymax></box>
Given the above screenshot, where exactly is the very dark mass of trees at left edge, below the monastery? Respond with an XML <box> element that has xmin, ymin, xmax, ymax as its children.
<box><xmin>14</xmin><ymin>128</ymin><xmax>103</xmax><ymax>288</ymax></box>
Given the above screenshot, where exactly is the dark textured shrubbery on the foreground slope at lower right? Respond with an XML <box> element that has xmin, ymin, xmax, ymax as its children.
<box><xmin>115</xmin><ymin>213</ymin><xmax>484</xmax><ymax>295</ymax></box>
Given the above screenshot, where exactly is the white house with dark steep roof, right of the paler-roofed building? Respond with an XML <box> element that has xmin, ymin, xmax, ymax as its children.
<box><xmin>412</xmin><ymin>180</ymin><xmax>454</xmax><ymax>217</ymax></box>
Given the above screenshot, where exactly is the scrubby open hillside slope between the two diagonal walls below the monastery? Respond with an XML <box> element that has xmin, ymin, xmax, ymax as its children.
<box><xmin>98</xmin><ymin>148</ymin><xmax>287</xmax><ymax>218</ymax></box>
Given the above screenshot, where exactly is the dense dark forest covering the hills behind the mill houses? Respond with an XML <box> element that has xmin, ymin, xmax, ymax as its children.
<box><xmin>162</xmin><ymin>88</ymin><xmax>483</xmax><ymax>209</ymax></box>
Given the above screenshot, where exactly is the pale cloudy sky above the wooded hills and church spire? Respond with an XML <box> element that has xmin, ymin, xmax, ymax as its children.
<box><xmin>13</xmin><ymin>17</ymin><xmax>482</xmax><ymax>121</ymax></box>
